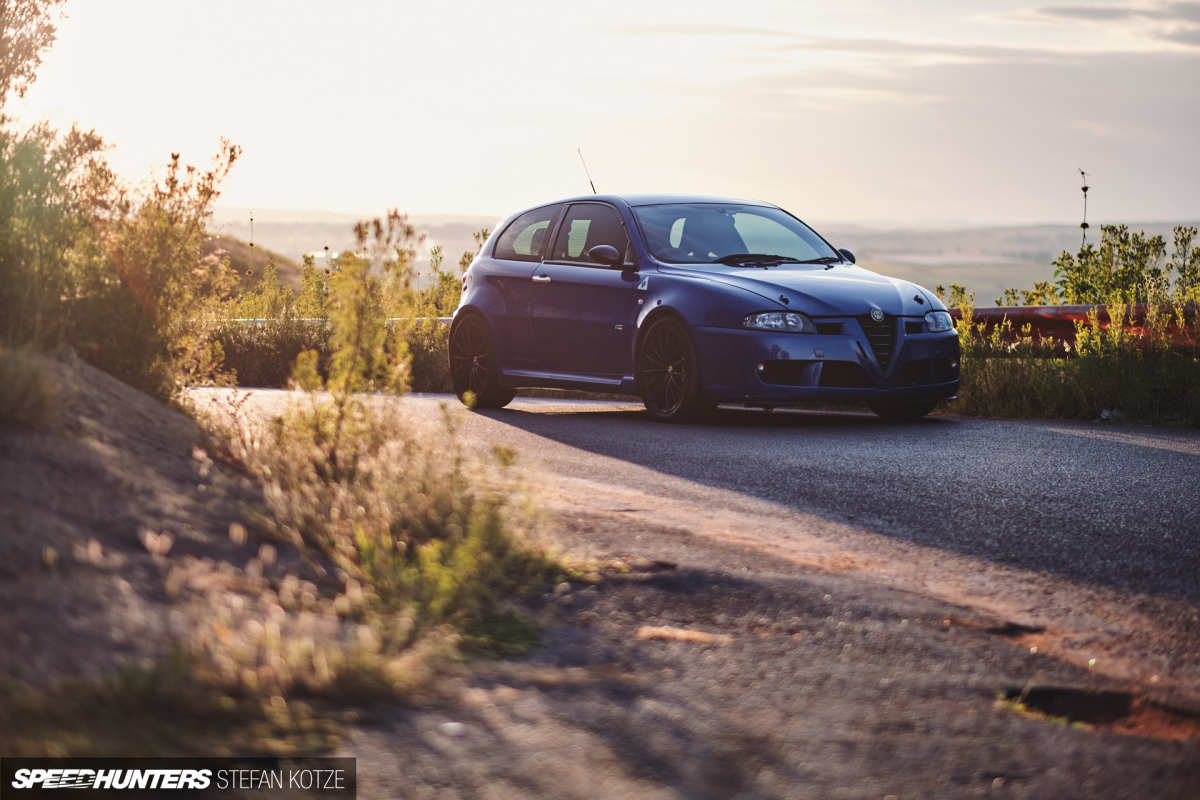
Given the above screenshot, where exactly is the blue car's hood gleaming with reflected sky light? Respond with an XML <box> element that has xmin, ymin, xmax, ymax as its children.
<box><xmin>672</xmin><ymin>265</ymin><xmax>944</xmax><ymax>317</ymax></box>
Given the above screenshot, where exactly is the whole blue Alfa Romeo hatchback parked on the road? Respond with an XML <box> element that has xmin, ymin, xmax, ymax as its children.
<box><xmin>450</xmin><ymin>196</ymin><xmax>959</xmax><ymax>421</ymax></box>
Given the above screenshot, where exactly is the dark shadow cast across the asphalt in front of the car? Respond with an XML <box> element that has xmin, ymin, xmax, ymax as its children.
<box><xmin>484</xmin><ymin>404</ymin><xmax>1200</xmax><ymax>602</ymax></box>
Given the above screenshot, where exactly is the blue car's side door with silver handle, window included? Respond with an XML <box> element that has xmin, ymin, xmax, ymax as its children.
<box><xmin>532</xmin><ymin>201</ymin><xmax>640</xmax><ymax>379</ymax></box>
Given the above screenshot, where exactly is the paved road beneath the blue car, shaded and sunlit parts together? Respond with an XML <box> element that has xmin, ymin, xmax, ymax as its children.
<box><xmin>424</xmin><ymin>397</ymin><xmax>1200</xmax><ymax>702</ymax></box>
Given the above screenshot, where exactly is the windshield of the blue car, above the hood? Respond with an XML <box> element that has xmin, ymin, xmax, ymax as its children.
<box><xmin>634</xmin><ymin>203</ymin><xmax>841</xmax><ymax>266</ymax></box>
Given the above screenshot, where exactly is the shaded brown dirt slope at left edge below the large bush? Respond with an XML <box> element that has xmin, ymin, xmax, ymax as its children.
<box><xmin>0</xmin><ymin>359</ymin><xmax>278</xmax><ymax>684</ymax></box>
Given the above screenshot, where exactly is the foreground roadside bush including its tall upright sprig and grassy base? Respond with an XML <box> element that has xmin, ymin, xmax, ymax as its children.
<box><xmin>192</xmin><ymin>217</ymin><xmax>562</xmax><ymax>693</ymax></box>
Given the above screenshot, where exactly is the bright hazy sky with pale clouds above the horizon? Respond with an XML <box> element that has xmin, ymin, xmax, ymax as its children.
<box><xmin>12</xmin><ymin>0</ymin><xmax>1200</xmax><ymax>225</ymax></box>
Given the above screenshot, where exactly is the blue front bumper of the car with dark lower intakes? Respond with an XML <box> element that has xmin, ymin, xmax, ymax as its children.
<box><xmin>692</xmin><ymin>325</ymin><xmax>960</xmax><ymax>404</ymax></box>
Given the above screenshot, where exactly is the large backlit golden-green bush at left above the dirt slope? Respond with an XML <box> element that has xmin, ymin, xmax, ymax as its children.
<box><xmin>0</xmin><ymin>119</ymin><xmax>239</xmax><ymax>397</ymax></box>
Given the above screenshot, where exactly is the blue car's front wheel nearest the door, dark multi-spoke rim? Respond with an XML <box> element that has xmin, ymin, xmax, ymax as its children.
<box><xmin>636</xmin><ymin>317</ymin><xmax>712</xmax><ymax>422</ymax></box>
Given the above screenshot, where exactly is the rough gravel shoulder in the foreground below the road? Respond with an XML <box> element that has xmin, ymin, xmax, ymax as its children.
<box><xmin>343</xmin><ymin>517</ymin><xmax>1200</xmax><ymax>799</ymax></box>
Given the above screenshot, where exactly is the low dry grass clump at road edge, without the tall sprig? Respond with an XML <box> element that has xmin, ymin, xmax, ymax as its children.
<box><xmin>193</xmin><ymin>395</ymin><xmax>563</xmax><ymax>697</ymax></box>
